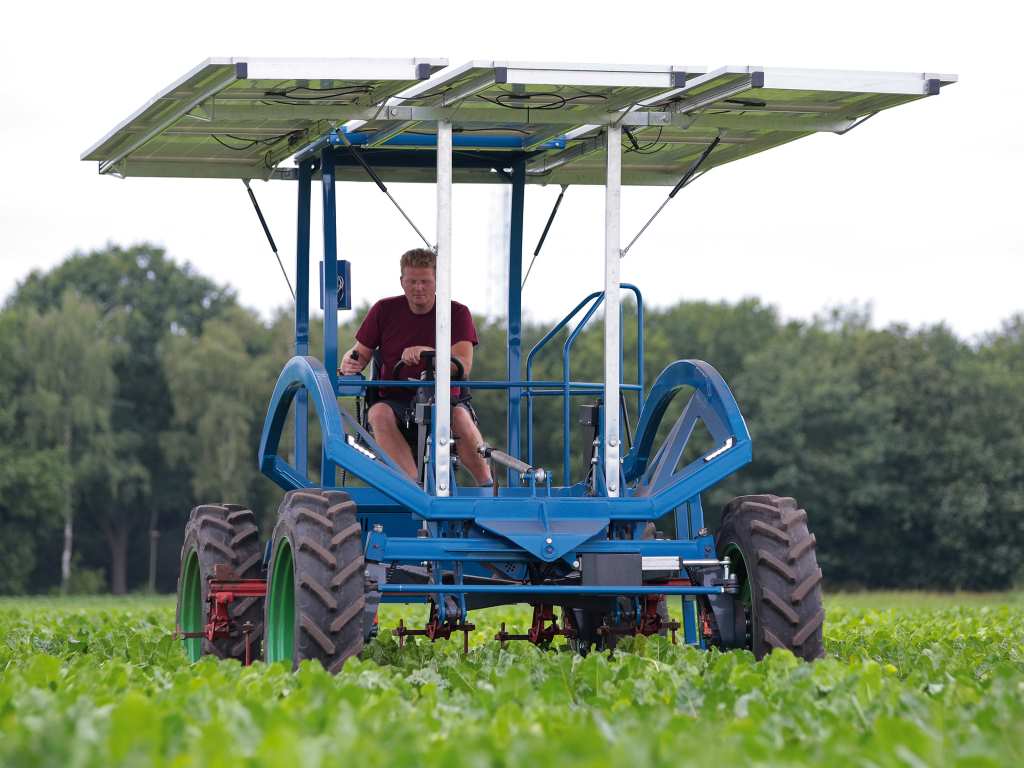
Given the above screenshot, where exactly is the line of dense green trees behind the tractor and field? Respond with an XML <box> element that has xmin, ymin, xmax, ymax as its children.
<box><xmin>0</xmin><ymin>245</ymin><xmax>1024</xmax><ymax>594</ymax></box>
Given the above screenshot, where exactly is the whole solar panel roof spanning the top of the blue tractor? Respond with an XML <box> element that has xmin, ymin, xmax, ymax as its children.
<box><xmin>83</xmin><ymin>58</ymin><xmax>956</xmax><ymax>184</ymax></box>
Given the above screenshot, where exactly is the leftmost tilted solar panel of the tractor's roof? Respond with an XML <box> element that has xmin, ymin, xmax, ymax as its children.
<box><xmin>82</xmin><ymin>58</ymin><xmax>446</xmax><ymax>178</ymax></box>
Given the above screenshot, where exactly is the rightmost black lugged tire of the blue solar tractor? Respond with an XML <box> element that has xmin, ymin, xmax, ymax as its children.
<box><xmin>716</xmin><ymin>495</ymin><xmax>825</xmax><ymax>662</ymax></box>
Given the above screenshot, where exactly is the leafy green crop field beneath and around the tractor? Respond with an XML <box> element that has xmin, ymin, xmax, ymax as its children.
<box><xmin>0</xmin><ymin>593</ymin><xmax>1024</xmax><ymax>768</ymax></box>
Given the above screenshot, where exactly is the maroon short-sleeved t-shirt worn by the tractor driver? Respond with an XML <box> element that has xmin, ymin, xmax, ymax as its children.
<box><xmin>355</xmin><ymin>295</ymin><xmax>479</xmax><ymax>400</ymax></box>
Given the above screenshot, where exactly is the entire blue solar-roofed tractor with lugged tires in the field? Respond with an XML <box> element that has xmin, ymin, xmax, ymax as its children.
<box><xmin>83</xmin><ymin>58</ymin><xmax>955</xmax><ymax>672</ymax></box>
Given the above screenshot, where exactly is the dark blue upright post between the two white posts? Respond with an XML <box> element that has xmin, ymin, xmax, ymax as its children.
<box><xmin>508</xmin><ymin>160</ymin><xmax>526</xmax><ymax>485</ymax></box>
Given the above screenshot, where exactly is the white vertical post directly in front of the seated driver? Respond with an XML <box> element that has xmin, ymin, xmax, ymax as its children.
<box><xmin>432</xmin><ymin>120</ymin><xmax>452</xmax><ymax>496</ymax></box>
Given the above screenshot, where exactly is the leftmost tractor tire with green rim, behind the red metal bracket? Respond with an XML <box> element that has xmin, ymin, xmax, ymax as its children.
<box><xmin>176</xmin><ymin>504</ymin><xmax>263</xmax><ymax>662</ymax></box>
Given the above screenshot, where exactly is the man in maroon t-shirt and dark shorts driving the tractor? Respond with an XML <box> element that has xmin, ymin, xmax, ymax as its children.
<box><xmin>341</xmin><ymin>248</ymin><xmax>492</xmax><ymax>485</ymax></box>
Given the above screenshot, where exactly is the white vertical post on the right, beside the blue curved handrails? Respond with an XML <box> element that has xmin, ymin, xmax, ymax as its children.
<box><xmin>603</xmin><ymin>125</ymin><xmax>623</xmax><ymax>497</ymax></box>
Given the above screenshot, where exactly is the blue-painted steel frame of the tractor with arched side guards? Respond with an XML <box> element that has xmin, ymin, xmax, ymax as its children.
<box><xmin>259</xmin><ymin>141</ymin><xmax>752</xmax><ymax>643</ymax></box>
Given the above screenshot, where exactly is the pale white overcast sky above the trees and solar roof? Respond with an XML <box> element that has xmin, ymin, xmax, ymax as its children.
<box><xmin>0</xmin><ymin>0</ymin><xmax>1024</xmax><ymax>336</ymax></box>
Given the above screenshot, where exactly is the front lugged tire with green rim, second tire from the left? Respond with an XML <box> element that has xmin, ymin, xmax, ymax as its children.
<box><xmin>264</xmin><ymin>488</ymin><xmax>372</xmax><ymax>674</ymax></box>
